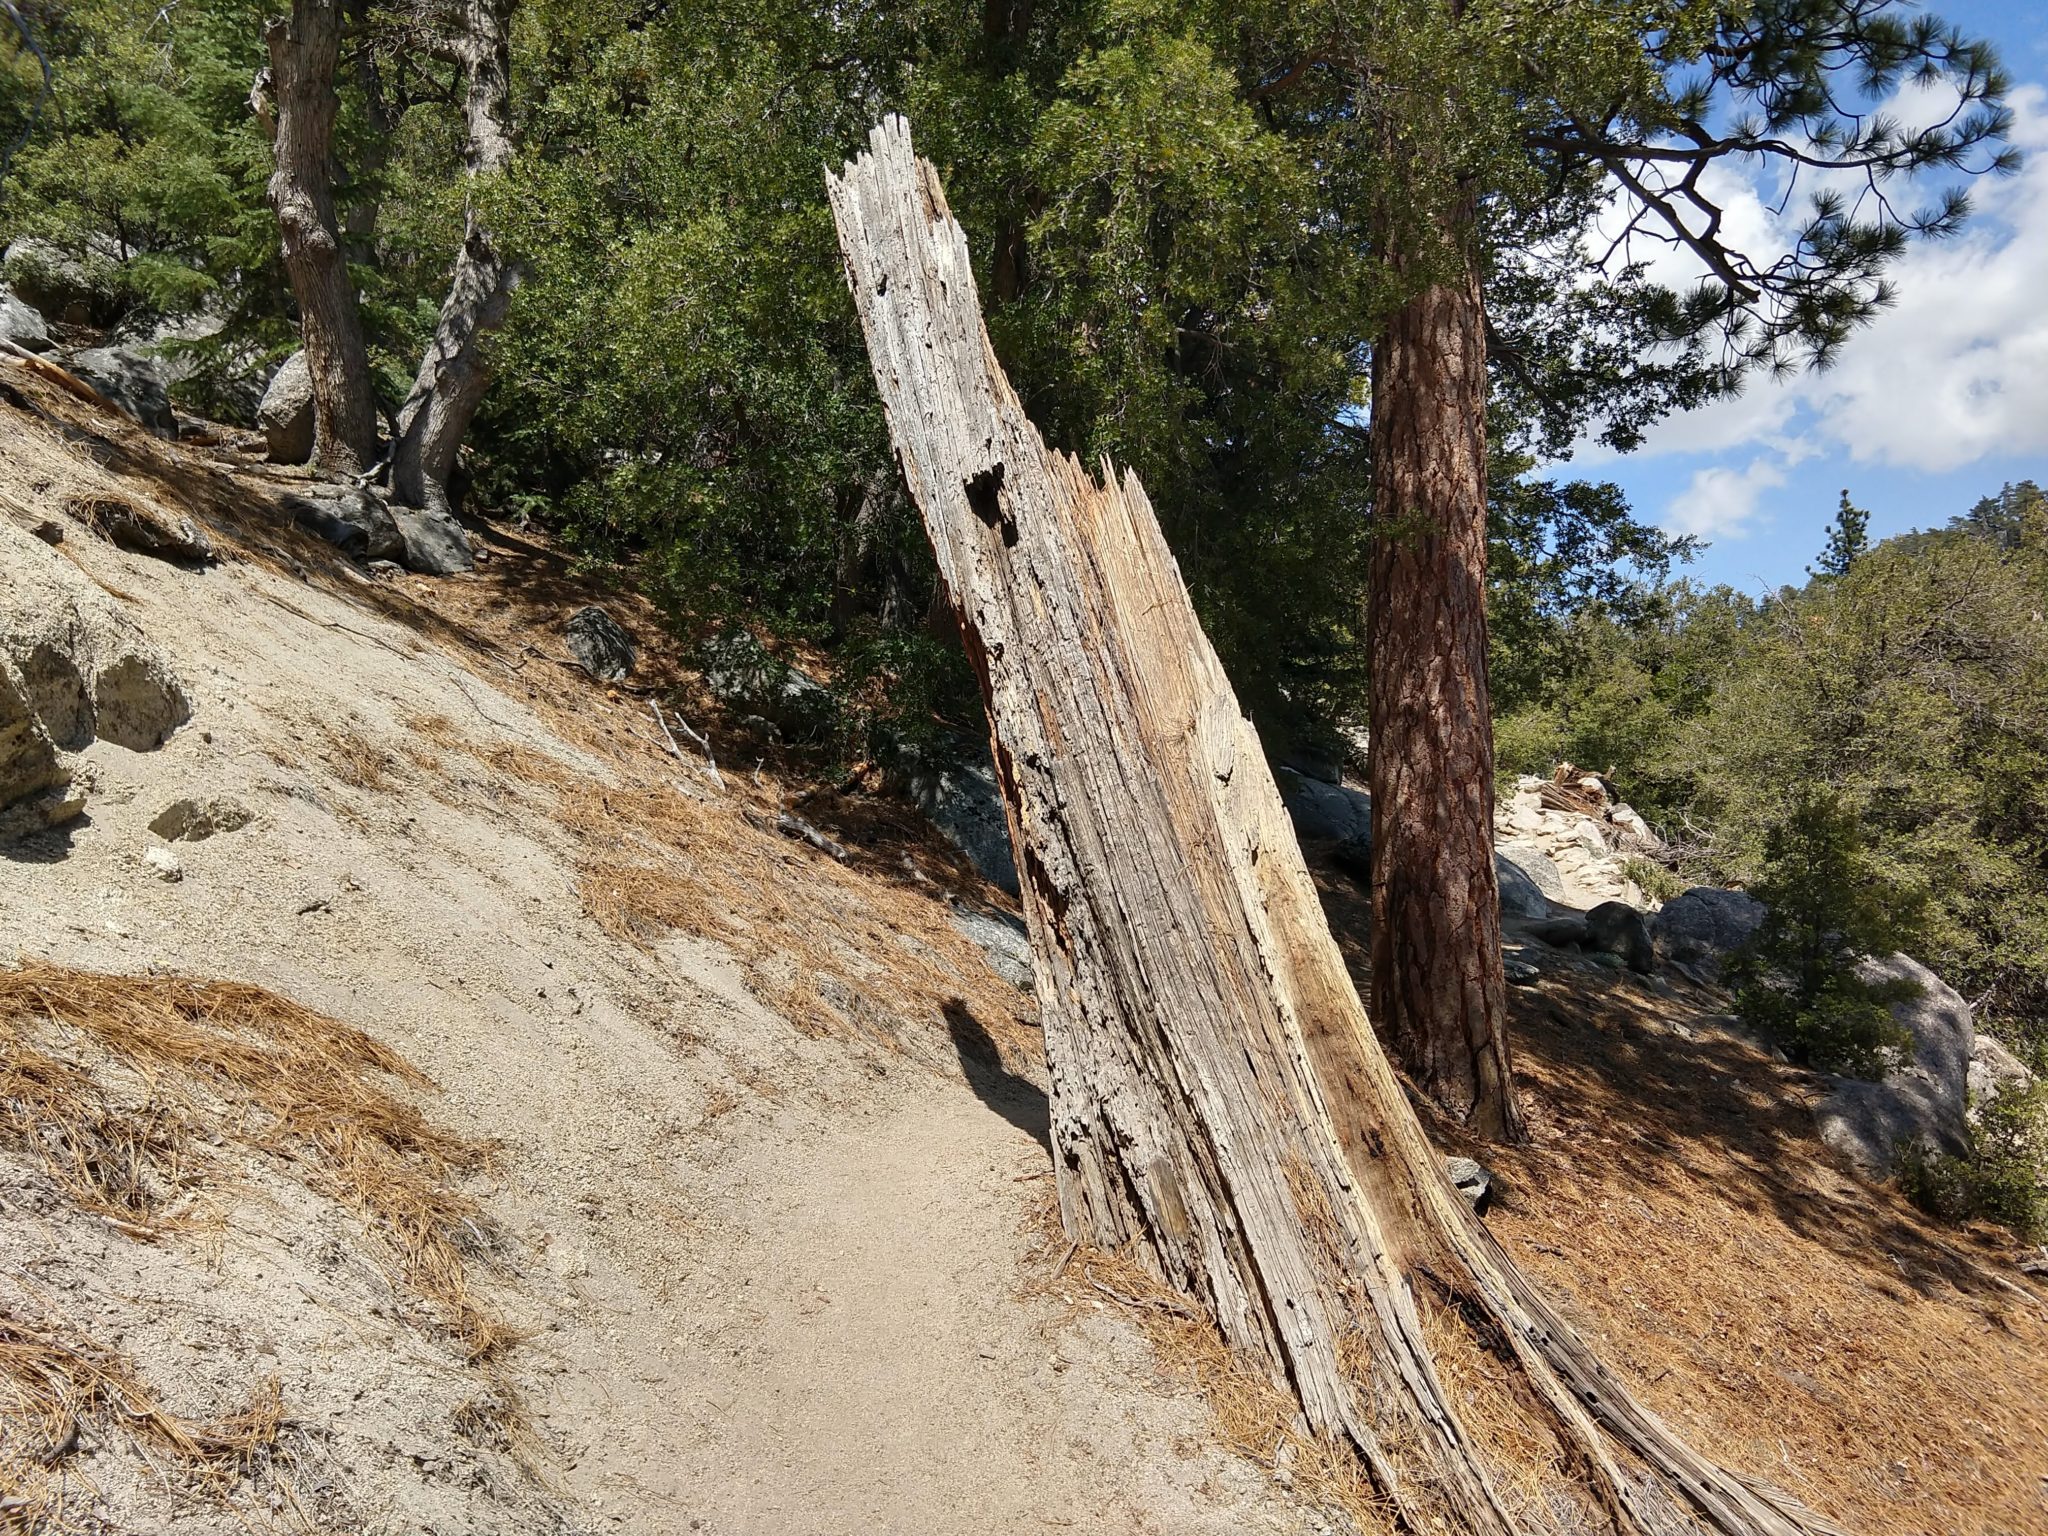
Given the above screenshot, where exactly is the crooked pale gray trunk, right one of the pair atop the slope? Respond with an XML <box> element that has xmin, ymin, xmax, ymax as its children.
<box><xmin>391</xmin><ymin>0</ymin><xmax>520</xmax><ymax>512</ymax></box>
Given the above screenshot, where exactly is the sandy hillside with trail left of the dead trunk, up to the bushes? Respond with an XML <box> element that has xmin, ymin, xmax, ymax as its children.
<box><xmin>0</xmin><ymin>379</ymin><xmax>1298</xmax><ymax>1536</ymax></box>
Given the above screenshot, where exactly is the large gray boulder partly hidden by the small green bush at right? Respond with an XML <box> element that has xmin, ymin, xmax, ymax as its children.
<box><xmin>1815</xmin><ymin>954</ymin><xmax>1976</xmax><ymax>1176</ymax></box>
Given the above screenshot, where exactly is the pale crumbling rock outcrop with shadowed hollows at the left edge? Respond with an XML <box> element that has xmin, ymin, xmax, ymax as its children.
<box><xmin>0</xmin><ymin>518</ymin><xmax>193</xmax><ymax>838</ymax></box>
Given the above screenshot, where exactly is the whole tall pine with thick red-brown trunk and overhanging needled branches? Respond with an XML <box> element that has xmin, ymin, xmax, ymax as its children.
<box><xmin>1233</xmin><ymin>0</ymin><xmax>2015</xmax><ymax>1137</ymax></box>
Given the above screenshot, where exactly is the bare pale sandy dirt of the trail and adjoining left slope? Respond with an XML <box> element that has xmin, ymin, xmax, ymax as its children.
<box><xmin>0</xmin><ymin>393</ymin><xmax>1309</xmax><ymax>1536</ymax></box>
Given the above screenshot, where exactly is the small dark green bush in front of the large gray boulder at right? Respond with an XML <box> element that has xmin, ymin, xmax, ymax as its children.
<box><xmin>1729</xmin><ymin>791</ymin><xmax>1919</xmax><ymax>1077</ymax></box>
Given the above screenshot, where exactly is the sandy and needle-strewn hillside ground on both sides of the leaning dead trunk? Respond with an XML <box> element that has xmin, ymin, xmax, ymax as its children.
<box><xmin>0</xmin><ymin>362</ymin><xmax>2048</xmax><ymax>1536</ymax></box>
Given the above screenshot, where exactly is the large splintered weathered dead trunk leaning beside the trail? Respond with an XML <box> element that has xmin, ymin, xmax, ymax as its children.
<box><xmin>827</xmin><ymin>117</ymin><xmax>1851</xmax><ymax>1536</ymax></box>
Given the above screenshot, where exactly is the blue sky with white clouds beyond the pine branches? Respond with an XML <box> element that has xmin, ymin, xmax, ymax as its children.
<box><xmin>1556</xmin><ymin>0</ymin><xmax>2048</xmax><ymax>592</ymax></box>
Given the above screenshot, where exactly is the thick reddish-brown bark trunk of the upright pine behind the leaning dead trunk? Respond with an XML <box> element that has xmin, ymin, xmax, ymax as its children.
<box><xmin>1368</xmin><ymin>256</ymin><xmax>1524</xmax><ymax>1141</ymax></box>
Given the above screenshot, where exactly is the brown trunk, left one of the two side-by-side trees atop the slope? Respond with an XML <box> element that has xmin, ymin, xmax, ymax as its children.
<box><xmin>252</xmin><ymin>0</ymin><xmax>377</xmax><ymax>475</ymax></box>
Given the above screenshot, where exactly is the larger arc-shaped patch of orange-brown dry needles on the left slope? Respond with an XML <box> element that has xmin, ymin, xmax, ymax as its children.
<box><xmin>0</xmin><ymin>961</ymin><xmax>516</xmax><ymax>1360</ymax></box>
